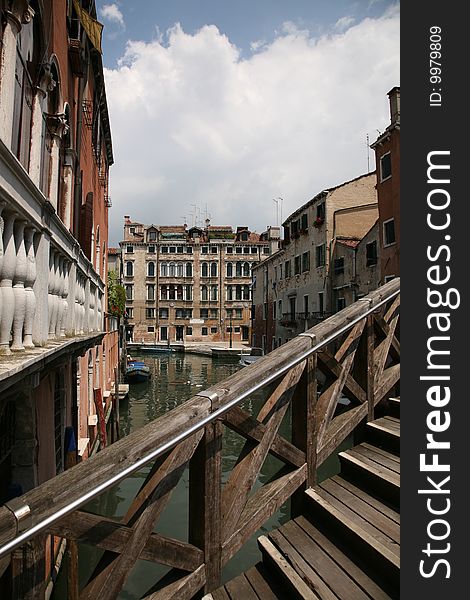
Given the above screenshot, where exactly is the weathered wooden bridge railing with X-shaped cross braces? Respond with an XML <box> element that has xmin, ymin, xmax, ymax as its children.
<box><xmin>0</xmin><ymin>279</ymin><xmax>400</xmax><ymax>600</ymax></box>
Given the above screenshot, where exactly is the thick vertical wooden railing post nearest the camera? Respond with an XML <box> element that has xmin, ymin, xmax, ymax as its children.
<box><xmin>189</xmin><ymin>420</ymin><xmax>223</xmax><ymax>592</ymax></box>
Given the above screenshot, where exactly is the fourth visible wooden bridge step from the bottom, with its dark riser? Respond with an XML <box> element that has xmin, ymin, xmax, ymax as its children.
<box><xmin>338</xmin><ymin>444</ymin><xmax>400</xmax><ymax>510</ymax></box>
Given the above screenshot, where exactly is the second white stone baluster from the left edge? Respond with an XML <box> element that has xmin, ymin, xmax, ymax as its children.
<box><xmin>11</xmin><ymin>219</ymin><xmax>28</xmax><ymax>352</ymax></box>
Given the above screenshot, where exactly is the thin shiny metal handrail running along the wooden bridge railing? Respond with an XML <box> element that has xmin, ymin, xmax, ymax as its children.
<box><xmin>0</xmin><ymin>282</ymin><xmax>400</xmax><ymax>558</ymax></box>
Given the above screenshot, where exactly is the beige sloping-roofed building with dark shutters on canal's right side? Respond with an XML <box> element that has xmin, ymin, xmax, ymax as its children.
<box><xmin>253</xmin><ymin>173</ymin><xmax>378</xmax><ymax>352</ymax></box>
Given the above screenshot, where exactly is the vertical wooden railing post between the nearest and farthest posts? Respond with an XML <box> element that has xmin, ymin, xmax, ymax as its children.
<box><xmin>291</xmin><ymin>353</ymin><xmax>317</xmax><ymax>516</ymax></box>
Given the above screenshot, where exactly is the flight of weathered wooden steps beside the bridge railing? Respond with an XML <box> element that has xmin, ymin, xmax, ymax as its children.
<box><xmin>204</xmin><ymin>399</ymin><xmax>400</xmax><ymax>600</ymax></box>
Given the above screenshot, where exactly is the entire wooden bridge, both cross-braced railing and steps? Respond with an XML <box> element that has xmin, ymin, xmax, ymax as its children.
<box><xmin>0</xmin><ymin>279</ymin><xmax>400</xmax><ymax>600</ymax></box>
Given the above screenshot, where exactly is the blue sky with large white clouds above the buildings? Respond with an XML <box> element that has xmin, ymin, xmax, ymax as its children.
<box><xmin>97</xmin><ymin>0</ymin><xmax>400</xmax><ymax>245</ymax></box>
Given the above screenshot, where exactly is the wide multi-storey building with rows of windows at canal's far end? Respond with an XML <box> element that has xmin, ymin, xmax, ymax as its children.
<box><xmin>120</xmin><ymin>217</ymin><xmax>279</xmax><ymax>344</ymax></box>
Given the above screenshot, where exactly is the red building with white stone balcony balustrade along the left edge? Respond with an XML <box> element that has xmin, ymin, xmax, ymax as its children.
<box><xmin>0</xmin><ymin>0</ymin><xmax>118</xmax><ymax>597</ymax></box>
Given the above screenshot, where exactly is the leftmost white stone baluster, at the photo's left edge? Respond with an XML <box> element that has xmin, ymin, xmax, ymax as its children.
<box><xmin>0</xmin><ymin>213</ymin><xmax>16</xmax><ymax>354</ymax></box>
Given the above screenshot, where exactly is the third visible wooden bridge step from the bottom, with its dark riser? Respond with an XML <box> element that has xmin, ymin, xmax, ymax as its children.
<box><xmin>305</xmin><ymin>480</ymin><xmax>400</xmax><ymax>595</ymax></box>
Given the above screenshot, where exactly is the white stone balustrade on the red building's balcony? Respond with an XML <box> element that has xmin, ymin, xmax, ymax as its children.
<box><xmin>0</xmin><ymin>140</ymin><xmax>105</xmax><ymax>355</ymax></box>
